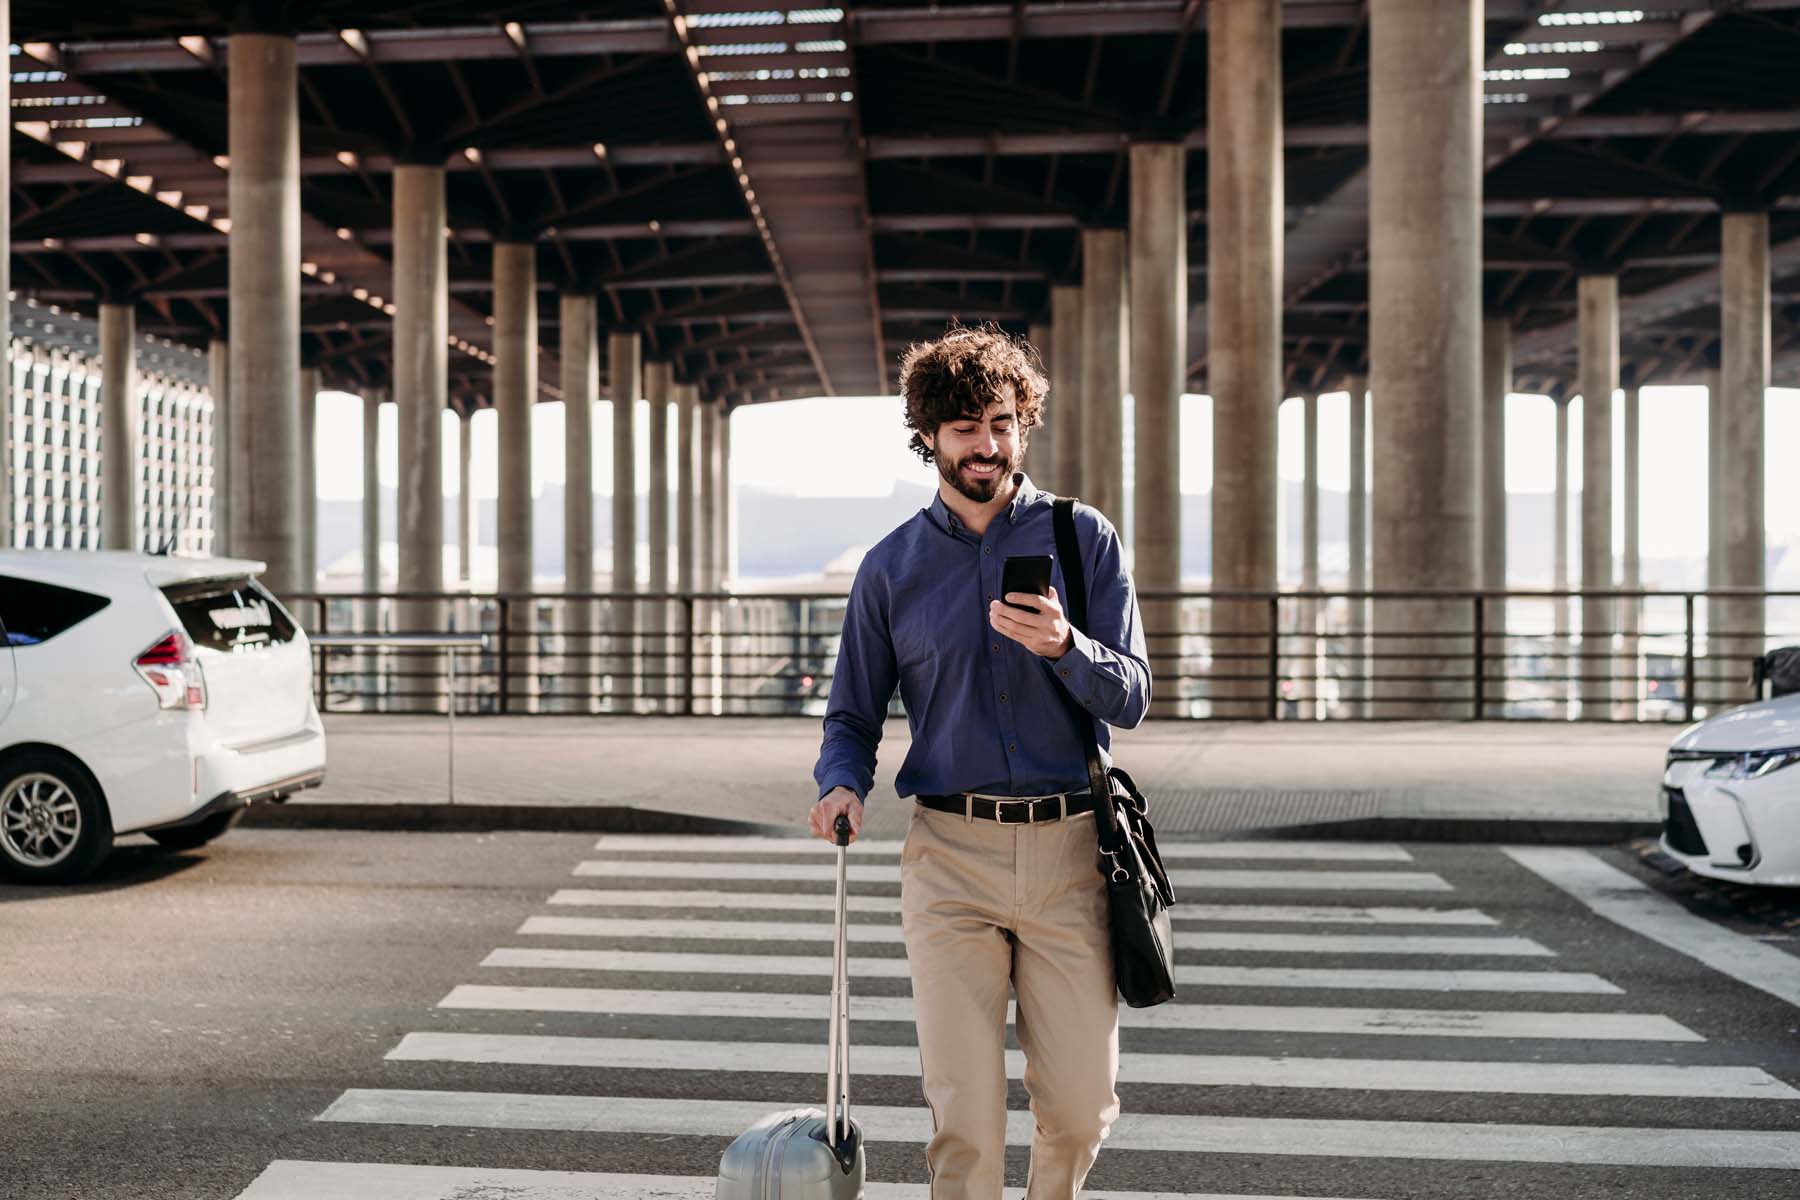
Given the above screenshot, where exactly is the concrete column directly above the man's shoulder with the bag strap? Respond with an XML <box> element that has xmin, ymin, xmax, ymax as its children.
<box><xmin>1082</xmin><ymin>228</ymin><xmax>1127</xmax><ymax>531</ymax></box>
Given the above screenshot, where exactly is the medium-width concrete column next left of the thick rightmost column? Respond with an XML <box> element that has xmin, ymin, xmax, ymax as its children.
<box><xmin>1575</xmin><ymin>275</ymin><xmax>1618</xmax><ymax>718</ymax></box>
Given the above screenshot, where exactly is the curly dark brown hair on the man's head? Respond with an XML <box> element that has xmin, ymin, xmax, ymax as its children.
<box><xmin>900</xmin><ymin>322</ymin><xmax>1049</xmax><ymax>464</ymax></box>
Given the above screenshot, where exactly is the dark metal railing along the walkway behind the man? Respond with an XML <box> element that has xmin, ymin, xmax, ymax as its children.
<box><xmin>290</xmin><ymin>588</ymin><xmax>1800</xmax><ymax>721</ymax></box>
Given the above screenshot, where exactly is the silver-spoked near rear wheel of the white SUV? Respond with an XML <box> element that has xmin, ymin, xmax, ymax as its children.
<box><xmin>0</xmin><ymin>750</ymin><xmax>112</xmax><ymax>883</ymax></box>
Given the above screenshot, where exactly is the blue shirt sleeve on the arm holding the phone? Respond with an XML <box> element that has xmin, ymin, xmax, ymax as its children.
<box><xmin>1048</xmin><ymin>515</ymin><xmax>1150</xmax><ymax>729</ymax></box>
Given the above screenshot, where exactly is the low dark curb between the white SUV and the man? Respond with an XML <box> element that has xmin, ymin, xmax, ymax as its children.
<box><xmin>239</xmin><ymin>801</ymin><xmax>799</xmax><ymax>837</ymax></box>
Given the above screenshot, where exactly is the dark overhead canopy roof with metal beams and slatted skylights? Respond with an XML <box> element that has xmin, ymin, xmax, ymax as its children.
<box><xmin>13</xmin><ymin>0</ymin><xmax>1800</xmax><ymax>408</ymax></box>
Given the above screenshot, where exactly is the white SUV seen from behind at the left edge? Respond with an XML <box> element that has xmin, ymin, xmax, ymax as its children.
<box><xmin>0</xmin><ymin>551</ymin><xmax>326</xmax><ymax>882</ymax></box>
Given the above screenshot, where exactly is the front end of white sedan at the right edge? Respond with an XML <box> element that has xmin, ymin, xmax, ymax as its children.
<box><xmin>1663</xmin><ymin>693</ymin><xmax>1800</xmax><ymax>887</ymax></box>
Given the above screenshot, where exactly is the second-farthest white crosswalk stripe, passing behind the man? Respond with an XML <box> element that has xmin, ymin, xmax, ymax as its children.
<box><xmin>576</xmin><ymin>858</ymin><xmax>1454</xmax><ymax>892</ymax></box>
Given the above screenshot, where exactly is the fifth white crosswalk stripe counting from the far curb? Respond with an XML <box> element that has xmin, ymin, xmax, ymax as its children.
<box><xmin>481</xmin><ymin>939</ymin><xmax>1620</xmax><ymax>995</ymax></box>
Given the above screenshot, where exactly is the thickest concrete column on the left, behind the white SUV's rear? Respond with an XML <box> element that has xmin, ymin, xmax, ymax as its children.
<box><xmin>227</xmin><ymin>32</ymin><xmax>300</xmax><ymax>596</ymax></box>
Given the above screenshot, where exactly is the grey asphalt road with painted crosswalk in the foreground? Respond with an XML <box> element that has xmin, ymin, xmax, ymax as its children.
<box><xmin>0</xmin><ymin>829</ymin><xmax>1800</xmax><ymax>1200</ymax></box>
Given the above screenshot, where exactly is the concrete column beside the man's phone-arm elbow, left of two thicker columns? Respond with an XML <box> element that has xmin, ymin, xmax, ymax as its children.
<box><xmin>1127</xmin><ymin>142</ymin><xmax>1188</xmax><ymax>716</ymax></box>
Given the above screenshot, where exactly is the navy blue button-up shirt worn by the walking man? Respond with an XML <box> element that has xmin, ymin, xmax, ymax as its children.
<box><xmin>812</xmin><ymin>471</ymin><xmax>1150</xmax><ymax>801</ymax></box>
